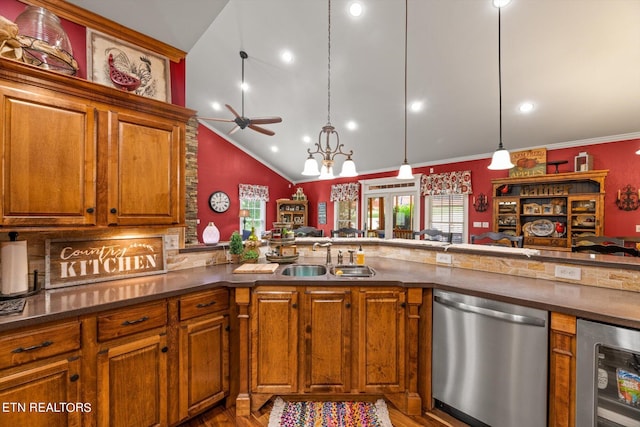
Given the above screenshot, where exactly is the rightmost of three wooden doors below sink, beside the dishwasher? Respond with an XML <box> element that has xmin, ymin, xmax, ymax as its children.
<box><xmin>357</xmin><ymin>289</ymin><xmax>406</xmax><ymax>392</ymax></box>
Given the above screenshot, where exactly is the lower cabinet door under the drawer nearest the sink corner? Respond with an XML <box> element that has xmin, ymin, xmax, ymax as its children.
<box><xmin>179</xmin><ymin>316</ymin><xmax>229</xmax><ymax>419</ymax></box>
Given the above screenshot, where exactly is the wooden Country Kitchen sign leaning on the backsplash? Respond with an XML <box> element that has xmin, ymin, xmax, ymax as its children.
<box><xmin>45</xmin><ymin>236</ymin><xmax>167</xmax><ymax>288</ymax></box>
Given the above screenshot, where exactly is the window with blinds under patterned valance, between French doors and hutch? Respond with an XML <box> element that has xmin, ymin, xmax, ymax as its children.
<box><xmin>425</xmin><ymin>194</ymin><xmax>469</xmax><ymax>243</ymax></box>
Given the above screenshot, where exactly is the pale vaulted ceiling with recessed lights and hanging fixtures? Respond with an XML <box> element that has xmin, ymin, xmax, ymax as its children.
<box><xmin>70</xmin><ymin>0</ymin><xmax>640</xmax><ymax>182</ymax></box>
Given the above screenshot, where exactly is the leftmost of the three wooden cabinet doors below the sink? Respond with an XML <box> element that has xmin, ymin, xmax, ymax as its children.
<box><xmin>251</xmin><ymin>288</ymin><xmax>298</xmax><ymax>393</ymax></box>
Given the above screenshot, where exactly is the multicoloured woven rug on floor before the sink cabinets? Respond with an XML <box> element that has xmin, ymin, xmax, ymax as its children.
<box><xmin>269</xmin><ymin>397</ymin><xmax>393</xmax><ymax>427</ymax></box>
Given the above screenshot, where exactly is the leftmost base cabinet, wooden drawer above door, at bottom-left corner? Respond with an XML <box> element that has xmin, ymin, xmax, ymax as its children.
<box><xmin>0</xmin><ymin>320</ymin><xmax>82</xmax><ymax>427</ymax></box>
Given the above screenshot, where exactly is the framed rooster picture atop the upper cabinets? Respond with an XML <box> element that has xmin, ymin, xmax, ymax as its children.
<box><xmin>87</xmin><ymin>28</ymin><xmax>171</xmax><ymax>102</ymax></box>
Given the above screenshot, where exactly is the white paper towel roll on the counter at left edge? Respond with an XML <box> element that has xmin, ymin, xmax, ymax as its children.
<box><xmin>0</xmin><ymin>240</ymin><xmax>29</xmax><ymax>295</ymax></box>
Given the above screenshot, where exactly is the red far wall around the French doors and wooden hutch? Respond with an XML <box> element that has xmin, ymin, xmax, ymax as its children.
<box><xmin>297</xmin><ymin>139</ymin><xmax>640</xmax><ymax>241</ymax></box>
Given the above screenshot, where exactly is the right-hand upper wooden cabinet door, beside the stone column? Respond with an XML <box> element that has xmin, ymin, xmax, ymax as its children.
<box><xmin>108</xmin><ymin>112</ymin><xmax>184</xmax><ymax>225</ymax></box>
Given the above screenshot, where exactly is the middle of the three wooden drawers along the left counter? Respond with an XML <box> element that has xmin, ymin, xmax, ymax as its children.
<box><xmin>98</xmin><ymin>301</ymin><xmax>167</xmax><ymax>341</ymax></box>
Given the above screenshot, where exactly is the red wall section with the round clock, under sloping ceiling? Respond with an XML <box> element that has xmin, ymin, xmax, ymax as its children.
<box><xmin>197</xmin><ymin>125</ymin><xmax>294</xmax><ymax>241</ymax></box>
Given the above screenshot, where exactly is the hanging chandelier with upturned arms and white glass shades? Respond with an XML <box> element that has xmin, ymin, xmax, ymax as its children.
<box><xmin>302</xmin><ymin>0</ymin><xmax>358</xmax><ymax>179</ymax></box>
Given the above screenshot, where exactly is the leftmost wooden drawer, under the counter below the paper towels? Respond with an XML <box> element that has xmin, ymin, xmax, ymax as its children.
<box><xmin>0</xmin><ymin>322</ymin><xmax>80</xmax><ymax>369</ymax></box>
